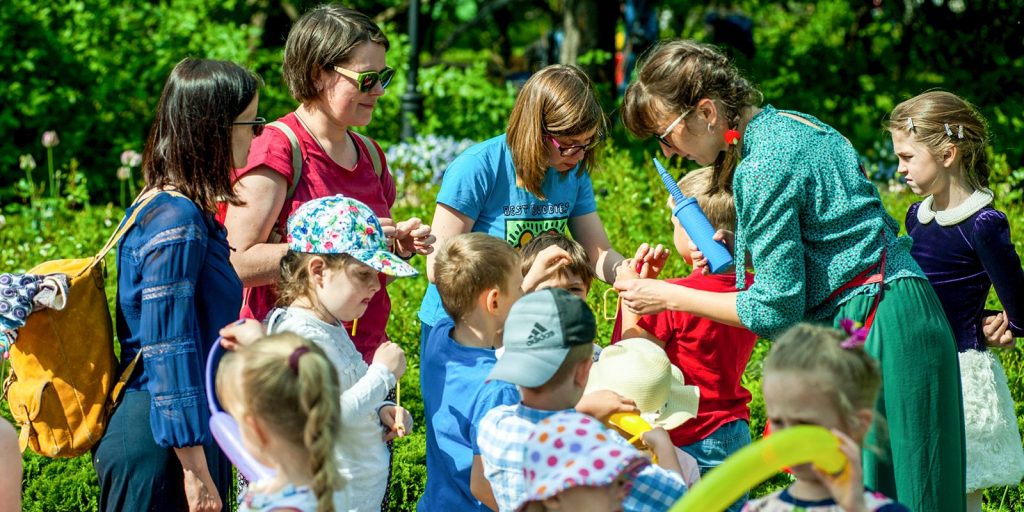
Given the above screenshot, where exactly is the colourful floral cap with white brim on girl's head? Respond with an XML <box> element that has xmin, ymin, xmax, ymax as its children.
<box><xmin>288</xmin><ymin>195</ymin><xmax>418</xmax><ymax>278</ymax></box>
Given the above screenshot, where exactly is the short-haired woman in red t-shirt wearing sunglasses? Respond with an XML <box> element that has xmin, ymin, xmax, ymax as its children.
<box><xmin>222</xmin><ymin>5</ymin><xmax>433</xmax><ymax>364</ymax></box>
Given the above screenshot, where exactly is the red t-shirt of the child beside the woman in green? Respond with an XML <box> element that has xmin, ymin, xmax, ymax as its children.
<box><xmin>612</xmin><ymin>272</ymin><xmax>758</xmax><ymax>446</ymax></box>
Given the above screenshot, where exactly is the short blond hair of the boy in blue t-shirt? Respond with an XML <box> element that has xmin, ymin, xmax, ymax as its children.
<box><xmin>434</xmin><ymin>232</ymin><xmax>519</xmax><ymax>322</ymax></box>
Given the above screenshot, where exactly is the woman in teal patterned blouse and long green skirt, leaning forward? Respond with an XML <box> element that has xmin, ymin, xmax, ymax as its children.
<box><xmin>615</xmin><ymin>41</ymin><xmax>965</xmax><ymax>511</ymax></box>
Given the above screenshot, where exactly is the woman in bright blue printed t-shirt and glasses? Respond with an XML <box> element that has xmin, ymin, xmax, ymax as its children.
<box><xmin>420</xmin><ymin>66</ymin><xmax>668</xmax><ymax>339</ymax></box>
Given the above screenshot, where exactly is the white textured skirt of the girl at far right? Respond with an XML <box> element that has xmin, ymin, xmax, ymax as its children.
<box><xmin>959</xmin><ymin>350</ymin><xmax>1024</xmax><ymax>493</ymax></box>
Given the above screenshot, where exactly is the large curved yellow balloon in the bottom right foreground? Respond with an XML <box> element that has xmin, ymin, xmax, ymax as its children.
<box><xmin>669</xmin><ymin>425</ymin><xmax>847</xmax><ymax>512</ymax></box>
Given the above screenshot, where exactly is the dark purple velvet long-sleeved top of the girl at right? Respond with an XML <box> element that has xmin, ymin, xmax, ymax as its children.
<box><xmin>906</xmin><ymin>203</ymin><xmax>1024</xmax><ymax>352</ymax></box>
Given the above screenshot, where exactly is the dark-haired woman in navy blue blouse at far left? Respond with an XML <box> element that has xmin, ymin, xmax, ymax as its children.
<box><xmin>92</xmin><ymin>58</ymin><xmax>264</xmax><ymax>512</ymax></box>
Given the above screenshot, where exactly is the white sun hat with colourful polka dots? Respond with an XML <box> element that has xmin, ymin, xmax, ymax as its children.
<box><xmin>517</xmin><ymin>412</ymin><xmax>650</xmax><ymax>511</ymax></box>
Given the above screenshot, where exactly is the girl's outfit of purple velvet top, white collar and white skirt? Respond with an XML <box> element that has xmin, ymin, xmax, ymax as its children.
<box><xmin>906</xmin><ymin>197</ymin><xmax>1024</xmax><ymax>493</ymax></box>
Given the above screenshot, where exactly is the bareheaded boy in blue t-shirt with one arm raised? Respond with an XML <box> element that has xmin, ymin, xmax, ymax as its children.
<box><xmin>416</xmin><ymin>232</ymin><xmax>568</xmax><ymax>512</ymax></box>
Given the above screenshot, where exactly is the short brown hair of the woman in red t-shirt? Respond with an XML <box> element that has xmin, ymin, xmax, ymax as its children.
<box><xmin>284</xmin><ymin>4</ymin><xmax>391</xmax><ymax>103</ymax></box>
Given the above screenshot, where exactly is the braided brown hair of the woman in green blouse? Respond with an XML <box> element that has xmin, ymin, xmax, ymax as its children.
<box><xmin>623</xmin><ymin>40</ymin><xmax>764</xmax><ymax>194</ymax></box>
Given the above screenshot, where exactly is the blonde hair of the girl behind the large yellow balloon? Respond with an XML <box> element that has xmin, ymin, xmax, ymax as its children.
<box><xmin>764</xmin><ymin>324</ymin><xmax>882</xmax><ymax>426</ymax></box>
